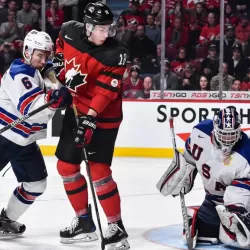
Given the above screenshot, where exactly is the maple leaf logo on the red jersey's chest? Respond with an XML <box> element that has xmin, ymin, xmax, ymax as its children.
<box><xmin>65</xmin><ymin>57</ymin><xmax>87</xmax><ymax>92</ymax></box>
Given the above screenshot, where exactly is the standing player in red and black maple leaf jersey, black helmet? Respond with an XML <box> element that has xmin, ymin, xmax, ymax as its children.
<box><xmin>54</xmin><ymin>2</ymin><xmax>129</xmax><ymax>250</ymax></box>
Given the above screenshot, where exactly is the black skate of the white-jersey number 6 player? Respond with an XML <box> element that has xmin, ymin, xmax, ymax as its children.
<box><xmin>0</xmin><ymin>208</ymin><xmax>26</xmax><ymax>237</ymax></box>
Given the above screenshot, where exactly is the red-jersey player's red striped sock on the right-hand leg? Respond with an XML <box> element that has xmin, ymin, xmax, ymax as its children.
<box><xmin>89</xmin><ymin>162</ymin><xmax>121</xmax><ymax>223</ymax></box>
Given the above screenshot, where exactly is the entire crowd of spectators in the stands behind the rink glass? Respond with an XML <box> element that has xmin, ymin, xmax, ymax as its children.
<box><xmin>0</xmin><ymin>0</ymin><xmax>250</xmax><ymax>99</ymax></box>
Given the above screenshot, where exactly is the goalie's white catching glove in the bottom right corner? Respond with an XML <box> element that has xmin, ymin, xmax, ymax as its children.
<box><xmin>216</xmin><ymin>205</ymin><xmax>250</xmax><ymax>249</ymax></box>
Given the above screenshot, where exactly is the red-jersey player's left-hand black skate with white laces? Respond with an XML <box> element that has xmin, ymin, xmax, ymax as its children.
<box><xmin>60</xmin><ymin>205</ymin><xmax>98</xmax><ymax>244</ymax></box>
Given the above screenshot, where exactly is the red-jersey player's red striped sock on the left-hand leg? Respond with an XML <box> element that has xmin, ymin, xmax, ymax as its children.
<box><xmin>57</xmin><ymin>160</ymin><xmax>88</xmax><ymax>216</ymax></box>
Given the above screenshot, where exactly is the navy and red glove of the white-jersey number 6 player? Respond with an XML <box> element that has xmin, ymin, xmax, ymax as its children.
<box><xmin>46</xmin><ymin>87</ymin><xmax>73</xmax><ymax>109</ymax></box>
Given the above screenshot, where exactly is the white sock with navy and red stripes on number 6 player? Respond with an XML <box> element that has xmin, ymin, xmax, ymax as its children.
<box><xmin>6</xmin><ymin>182</ymin><xmax>46</xmax><ymax>221</ymax></box>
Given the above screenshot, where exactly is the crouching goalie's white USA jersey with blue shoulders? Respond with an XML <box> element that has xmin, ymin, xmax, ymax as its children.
<box><xmin>184</xmin><ymin>120</ymin><xmax>250</xmax><ymax>211</ymax></box>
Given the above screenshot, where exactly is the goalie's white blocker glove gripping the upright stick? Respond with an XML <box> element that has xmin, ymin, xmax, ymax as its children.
<box><xmin>156</xmin><ymin>150</ymin><xmax>197</xmax><ymax>196</ymax></box>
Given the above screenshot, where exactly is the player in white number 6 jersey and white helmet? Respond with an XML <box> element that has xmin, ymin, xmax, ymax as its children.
<box><xmin>0</xmin><ymin>30</ymin><xmax>72</xmax><ymax>236</ymax></box>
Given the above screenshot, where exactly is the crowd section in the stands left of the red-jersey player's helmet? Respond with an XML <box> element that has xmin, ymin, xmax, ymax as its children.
<box><xmin>0</xmin><ymin>0</ymin><xmax>91</xmax><ymax>79</ymax></box>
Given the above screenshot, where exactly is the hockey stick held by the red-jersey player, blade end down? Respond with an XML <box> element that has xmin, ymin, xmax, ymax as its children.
<box><xmin>73</xmin><ymin>104</ymin><xmax>105</xmax><ymax>250</ymax></box>
